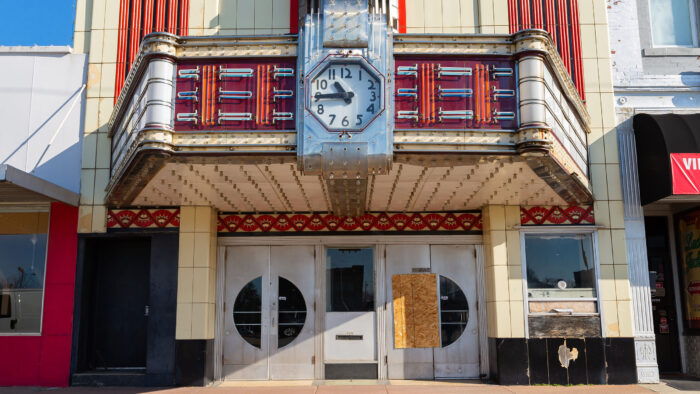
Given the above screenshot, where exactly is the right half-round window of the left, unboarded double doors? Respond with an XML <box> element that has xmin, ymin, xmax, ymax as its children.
<box><xmin>277</xmin><ymin>276</ymin><xmax>306</xmax><ymax>349</ymax></box>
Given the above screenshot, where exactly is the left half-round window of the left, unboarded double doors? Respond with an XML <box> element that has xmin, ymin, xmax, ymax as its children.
<box><xmin>233</xmin><ymin>276</ymin><xmax>262</xmax><ymax>349</ymax></box>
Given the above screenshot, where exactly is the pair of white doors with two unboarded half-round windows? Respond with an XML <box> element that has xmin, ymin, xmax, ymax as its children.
<box><xmin>223</xmin><ymin>245</ymin><xmax>314</xmax><ymax>380</ymax></box>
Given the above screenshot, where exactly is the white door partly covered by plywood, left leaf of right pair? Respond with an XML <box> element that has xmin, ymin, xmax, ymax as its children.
<box><xmin>385</xmin><ymin>245</ymin><xmax>434</xmax><ymax>379</ymax></box>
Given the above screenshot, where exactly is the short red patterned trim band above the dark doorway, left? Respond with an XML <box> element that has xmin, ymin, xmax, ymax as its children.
<box><xmin>107</xmin><ymin>208</ymin><xmax>180</xmax><ymax>228</ymax></box>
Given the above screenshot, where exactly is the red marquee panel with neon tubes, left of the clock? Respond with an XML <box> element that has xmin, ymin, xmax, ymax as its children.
<box><xmin>175</xmin><ymin>58</ymin><xmax>296</xmax><ymax>131</ymax></box>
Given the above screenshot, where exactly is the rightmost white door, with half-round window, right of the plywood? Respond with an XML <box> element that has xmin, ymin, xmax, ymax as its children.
<box><xmin>430</xmin><ymin>245</ymin><xmax>484</xmax><ymax>378</ymax></box>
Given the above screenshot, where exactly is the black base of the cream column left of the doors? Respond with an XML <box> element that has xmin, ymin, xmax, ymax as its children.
<box><xmin>175</xmin><ymin>339</ymin><xmax>214</xmax><ymax>386</ymax></box>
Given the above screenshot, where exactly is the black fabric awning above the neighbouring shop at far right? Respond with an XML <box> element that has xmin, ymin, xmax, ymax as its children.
<box><xmin>633</xmin><ymin>114</ymin><xmax>700</xmax><ymax>205</ymax></box>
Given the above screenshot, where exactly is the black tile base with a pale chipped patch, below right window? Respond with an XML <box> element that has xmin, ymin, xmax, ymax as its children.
<box><xmin>489</xmin><ymin>337</ymin><xmax>637</xmax><ymax>385</ymax></box>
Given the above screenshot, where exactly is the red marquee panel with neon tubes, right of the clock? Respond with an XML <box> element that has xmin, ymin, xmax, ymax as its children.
<box><xmin>395</xmin><ymin>57</ymin><xmax>517</xmax><ymax>129</ymax></box>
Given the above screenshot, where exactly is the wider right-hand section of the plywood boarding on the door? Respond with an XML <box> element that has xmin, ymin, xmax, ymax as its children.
<box><xmin>411</xmin><ymin>274</ymin><xmax>440</xmax><ymax>348</ymax></box>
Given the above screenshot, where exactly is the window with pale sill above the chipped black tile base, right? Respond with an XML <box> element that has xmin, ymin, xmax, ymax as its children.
<box><xmin>525</xmin><ymin>234</ymin><xmax>596</xmax><ymax>299</ymax></box>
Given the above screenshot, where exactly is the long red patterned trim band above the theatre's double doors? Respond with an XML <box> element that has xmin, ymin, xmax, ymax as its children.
<box><xmin>218</xmin><ymin>212</ymin><xmax>481</xmax><ymax>233</ymax></box>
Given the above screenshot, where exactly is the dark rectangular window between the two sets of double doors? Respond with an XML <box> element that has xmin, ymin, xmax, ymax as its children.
<box><xmin>326</xmin><ymin>248</ymin><xmax>374</xmax><ymax>312</ymax></box>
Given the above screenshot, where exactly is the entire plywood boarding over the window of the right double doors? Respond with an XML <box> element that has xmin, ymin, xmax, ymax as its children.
<box><xmin>391</xmin><ymin>274</ymin><xmax>440</xmax><ymax>349</ymax></box>
